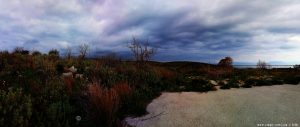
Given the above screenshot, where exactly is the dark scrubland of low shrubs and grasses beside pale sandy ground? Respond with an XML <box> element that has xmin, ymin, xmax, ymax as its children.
<box><xmin>0</xmin><ymin>39</ymin><xmax>300</xmax><ymax>127</ymax></box>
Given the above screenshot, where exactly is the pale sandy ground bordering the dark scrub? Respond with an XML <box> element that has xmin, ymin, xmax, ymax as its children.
<box><xmin>125</xmin><ymin>85</ymin><xmax>300</xmax><ymax>127</ymax></box>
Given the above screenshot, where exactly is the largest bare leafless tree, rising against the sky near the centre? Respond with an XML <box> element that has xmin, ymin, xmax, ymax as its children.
<box><xmin>128</xmin><ymin>37</ymin><xmax>157</xmax><ymax>62</ymax></box>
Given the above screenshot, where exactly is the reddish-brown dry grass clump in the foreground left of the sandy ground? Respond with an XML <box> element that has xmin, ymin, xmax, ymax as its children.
<box><xmin>88</xmin><ymin>82</ymin><xmax>131</xmax><ymax>127</ymax></box>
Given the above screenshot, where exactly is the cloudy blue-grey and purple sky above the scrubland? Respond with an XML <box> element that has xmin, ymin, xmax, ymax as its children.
<box><xmin>0</xmin><ymin>0</ymin><xmax>300</xmax><ymax>64</ymax></box>
